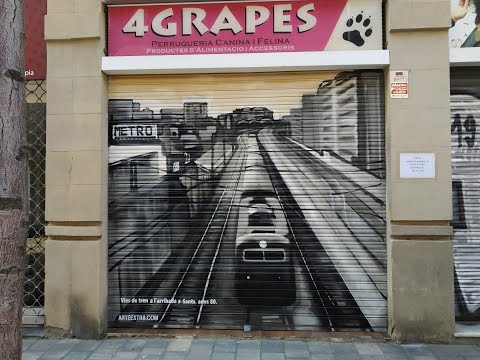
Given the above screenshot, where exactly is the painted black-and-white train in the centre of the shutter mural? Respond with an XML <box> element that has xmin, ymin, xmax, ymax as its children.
<box><xmin>235</xmin><ymin>134</ymin><xmax>296</xmax><ymax>306</ymax></box>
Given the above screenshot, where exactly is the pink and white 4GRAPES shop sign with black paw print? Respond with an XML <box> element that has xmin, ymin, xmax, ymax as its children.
<box><xmin>108</xmin><ymin>0</ymin><xmax>382</xmax><ymax>56</ymax></box>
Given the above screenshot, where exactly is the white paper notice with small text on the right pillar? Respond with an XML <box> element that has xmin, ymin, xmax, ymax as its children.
<box><xmin>400</xmin><ymin>153</ymin><xmax>435</xmax><ymax>179</ymax></box>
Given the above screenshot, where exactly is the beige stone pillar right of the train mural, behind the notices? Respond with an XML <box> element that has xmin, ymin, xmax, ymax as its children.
<box><xmin>386</xmin><ymin>0</ymin><xmax>455</xmax><ymax>341</ymax></box>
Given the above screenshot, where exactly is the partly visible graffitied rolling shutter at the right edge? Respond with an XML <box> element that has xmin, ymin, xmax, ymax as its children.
<box><xmin>451</xmin><ymin>68</ymin><xmax>480</xmax><ymax>321</ymax></box>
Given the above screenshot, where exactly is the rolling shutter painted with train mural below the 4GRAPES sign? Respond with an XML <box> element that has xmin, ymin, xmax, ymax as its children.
<box><xmin>108</xmin><ymin>71</ymin><xmax>387</xmax><ymax>331</ymax></box>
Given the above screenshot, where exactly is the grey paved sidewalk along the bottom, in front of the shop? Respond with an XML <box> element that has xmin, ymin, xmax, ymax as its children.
<box><xmin>20</xmin><ymin>338</ymin><xmax>480</xmax><ymax>360</ymax></box>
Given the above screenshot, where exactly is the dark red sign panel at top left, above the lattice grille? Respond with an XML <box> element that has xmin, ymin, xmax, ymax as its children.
<box><xmin>25</xmin><ymin>0</ymin><xmax>47</xmax><ymax>80</ymax></box>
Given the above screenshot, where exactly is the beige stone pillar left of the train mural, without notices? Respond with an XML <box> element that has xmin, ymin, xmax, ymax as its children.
<box><xmin>45</xmin><ymin>0</ymin><xmax>108</xmax><ymax>338</ymax></box>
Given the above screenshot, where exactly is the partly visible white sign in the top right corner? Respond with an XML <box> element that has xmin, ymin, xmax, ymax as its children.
<box><xmin>449</xmin><ymin>0</ymin><xmax>480</xmax><ymax>48</ymax></box>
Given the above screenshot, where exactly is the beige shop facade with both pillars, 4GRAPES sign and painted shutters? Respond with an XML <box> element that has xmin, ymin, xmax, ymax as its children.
<box><xmin>40</xmin><ymin>0</ymin><xmax>480</xmax><ymax>341</ymax></box>
